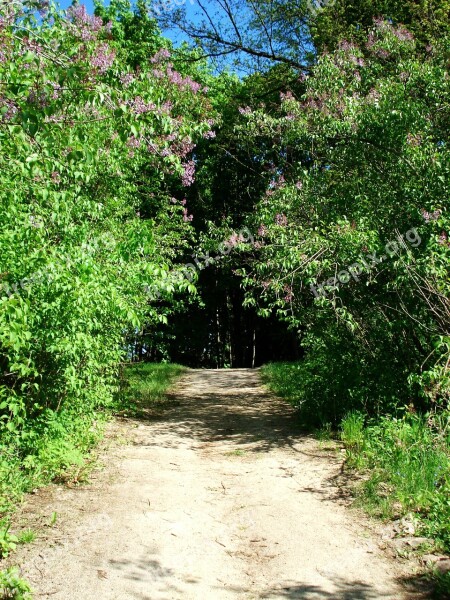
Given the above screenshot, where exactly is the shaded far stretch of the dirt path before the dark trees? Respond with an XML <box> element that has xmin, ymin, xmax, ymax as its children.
<box><xmin>128</xmin><ymin>369</ymin><xmax>314</xmax><ymax>458</ymax></box>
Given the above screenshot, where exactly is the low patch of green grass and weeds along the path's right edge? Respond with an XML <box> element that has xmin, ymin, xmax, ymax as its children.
<box><xmin>343</xmin><ymin>415</ymin><xmax>450</xmax><ymax>550</ymax></box>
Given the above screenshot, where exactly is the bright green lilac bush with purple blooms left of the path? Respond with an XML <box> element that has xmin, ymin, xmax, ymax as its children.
<box><xmin>0</xmin><ymin>1</ymin><xmax>213</xmax><ymax>516</ymax></box>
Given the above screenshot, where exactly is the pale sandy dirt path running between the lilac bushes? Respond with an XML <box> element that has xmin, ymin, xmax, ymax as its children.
<box><xmin>13</xmin><ymin>370</ymin><xmax>422</xmax><ymax>600</ymax></box>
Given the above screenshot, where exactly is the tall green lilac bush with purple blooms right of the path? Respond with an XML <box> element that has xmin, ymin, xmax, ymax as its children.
<box><xmin>243</xmin><ymin>21</ymin><xmax>450</xmax><ymax>423</ymax></box>
